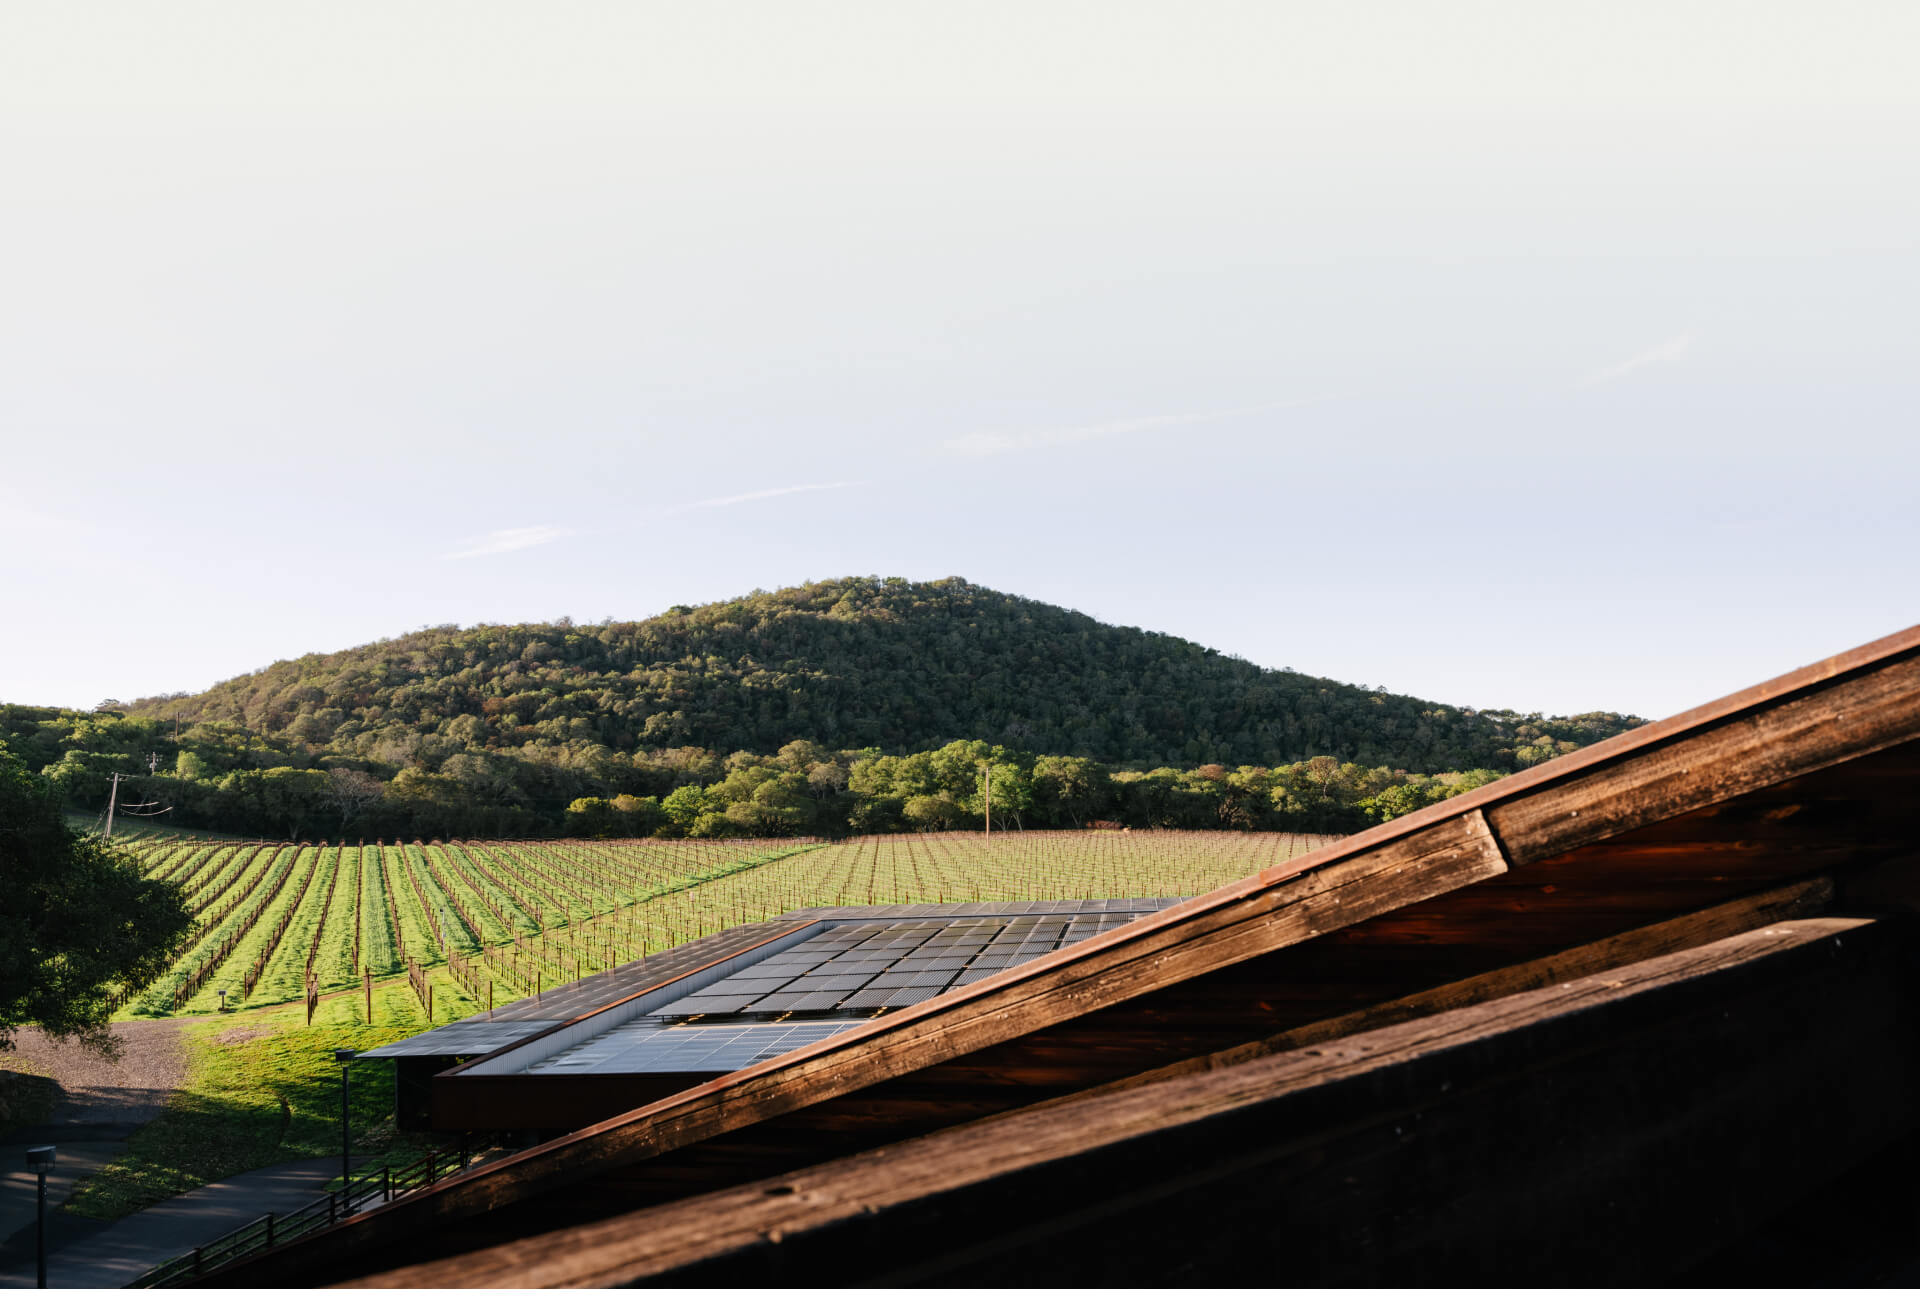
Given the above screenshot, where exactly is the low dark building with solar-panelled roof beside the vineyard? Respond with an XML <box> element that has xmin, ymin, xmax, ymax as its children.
<box><xmin>361</xmin><ymin>898</ymin><xmax>1179</xmax><ymax>1130</ymax></box>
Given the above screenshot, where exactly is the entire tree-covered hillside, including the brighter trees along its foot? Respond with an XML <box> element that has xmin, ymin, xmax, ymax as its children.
<box><xmin>0</xmin><ymin>578</ymin><xmax>1640</xmax><ymax>839</ymax></box>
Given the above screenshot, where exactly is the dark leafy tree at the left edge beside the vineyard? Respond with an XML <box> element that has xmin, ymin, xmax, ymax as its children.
<box><xmin>0</xmin><ymin>750</ymin><xmax>192</xmax><ymax>1050</ymax></box>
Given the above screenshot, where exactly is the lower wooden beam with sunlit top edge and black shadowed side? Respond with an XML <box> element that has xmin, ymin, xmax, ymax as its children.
<box><xmin>341</xmin><ymin>917</ymin><xmax>1920</xmax><ymax>1288</ymax></box>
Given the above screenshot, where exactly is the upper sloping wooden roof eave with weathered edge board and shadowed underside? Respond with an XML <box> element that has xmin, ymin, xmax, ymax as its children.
<box><xmin>219</xmin><ymin>627</ymin><xmax>1920</xmax><ymax>1284</ymax></box>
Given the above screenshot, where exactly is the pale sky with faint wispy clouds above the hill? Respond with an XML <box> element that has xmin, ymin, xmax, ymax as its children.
<box><xmin>0</xmin><ymin>0</ymin><xmax>1920</xmax><ymax>716</ymax></box>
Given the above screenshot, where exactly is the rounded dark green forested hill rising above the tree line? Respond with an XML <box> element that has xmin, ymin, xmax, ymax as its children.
<box><xmin>129</xmin><ymin>578</ymin><xmax>1640</xmax><ymax>773</ymax></box>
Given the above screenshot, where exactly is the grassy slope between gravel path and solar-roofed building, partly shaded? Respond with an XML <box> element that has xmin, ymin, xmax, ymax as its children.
<box><xmin>67</xmin><ymin>977</ymin><xmax>478</xmax><ymax>1220</ymax></box>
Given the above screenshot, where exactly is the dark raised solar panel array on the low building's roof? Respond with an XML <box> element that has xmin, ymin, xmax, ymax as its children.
<box><xmin>655</xmin><ymin>911</ymin><xmax>1139</xmax><ymax>1023</ymax></box>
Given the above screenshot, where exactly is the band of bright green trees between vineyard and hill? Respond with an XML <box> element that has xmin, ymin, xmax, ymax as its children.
<box><xmin>11</xmin><ymin>706</ymin><xmax>1512</xmax><ymax>840</ymax></box>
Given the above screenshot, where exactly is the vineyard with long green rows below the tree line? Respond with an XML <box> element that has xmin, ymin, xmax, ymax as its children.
<box><xmin>108</xmin><ymin>831</ymin><xmax>1331</xmax><ymax>1021</ymax></box>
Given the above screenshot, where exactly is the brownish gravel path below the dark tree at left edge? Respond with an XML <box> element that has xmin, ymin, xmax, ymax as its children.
<box><xmin>0</xmin><ymin>1021</ymin><xmax>186</xmax><ymax>1144</ymax></box>
